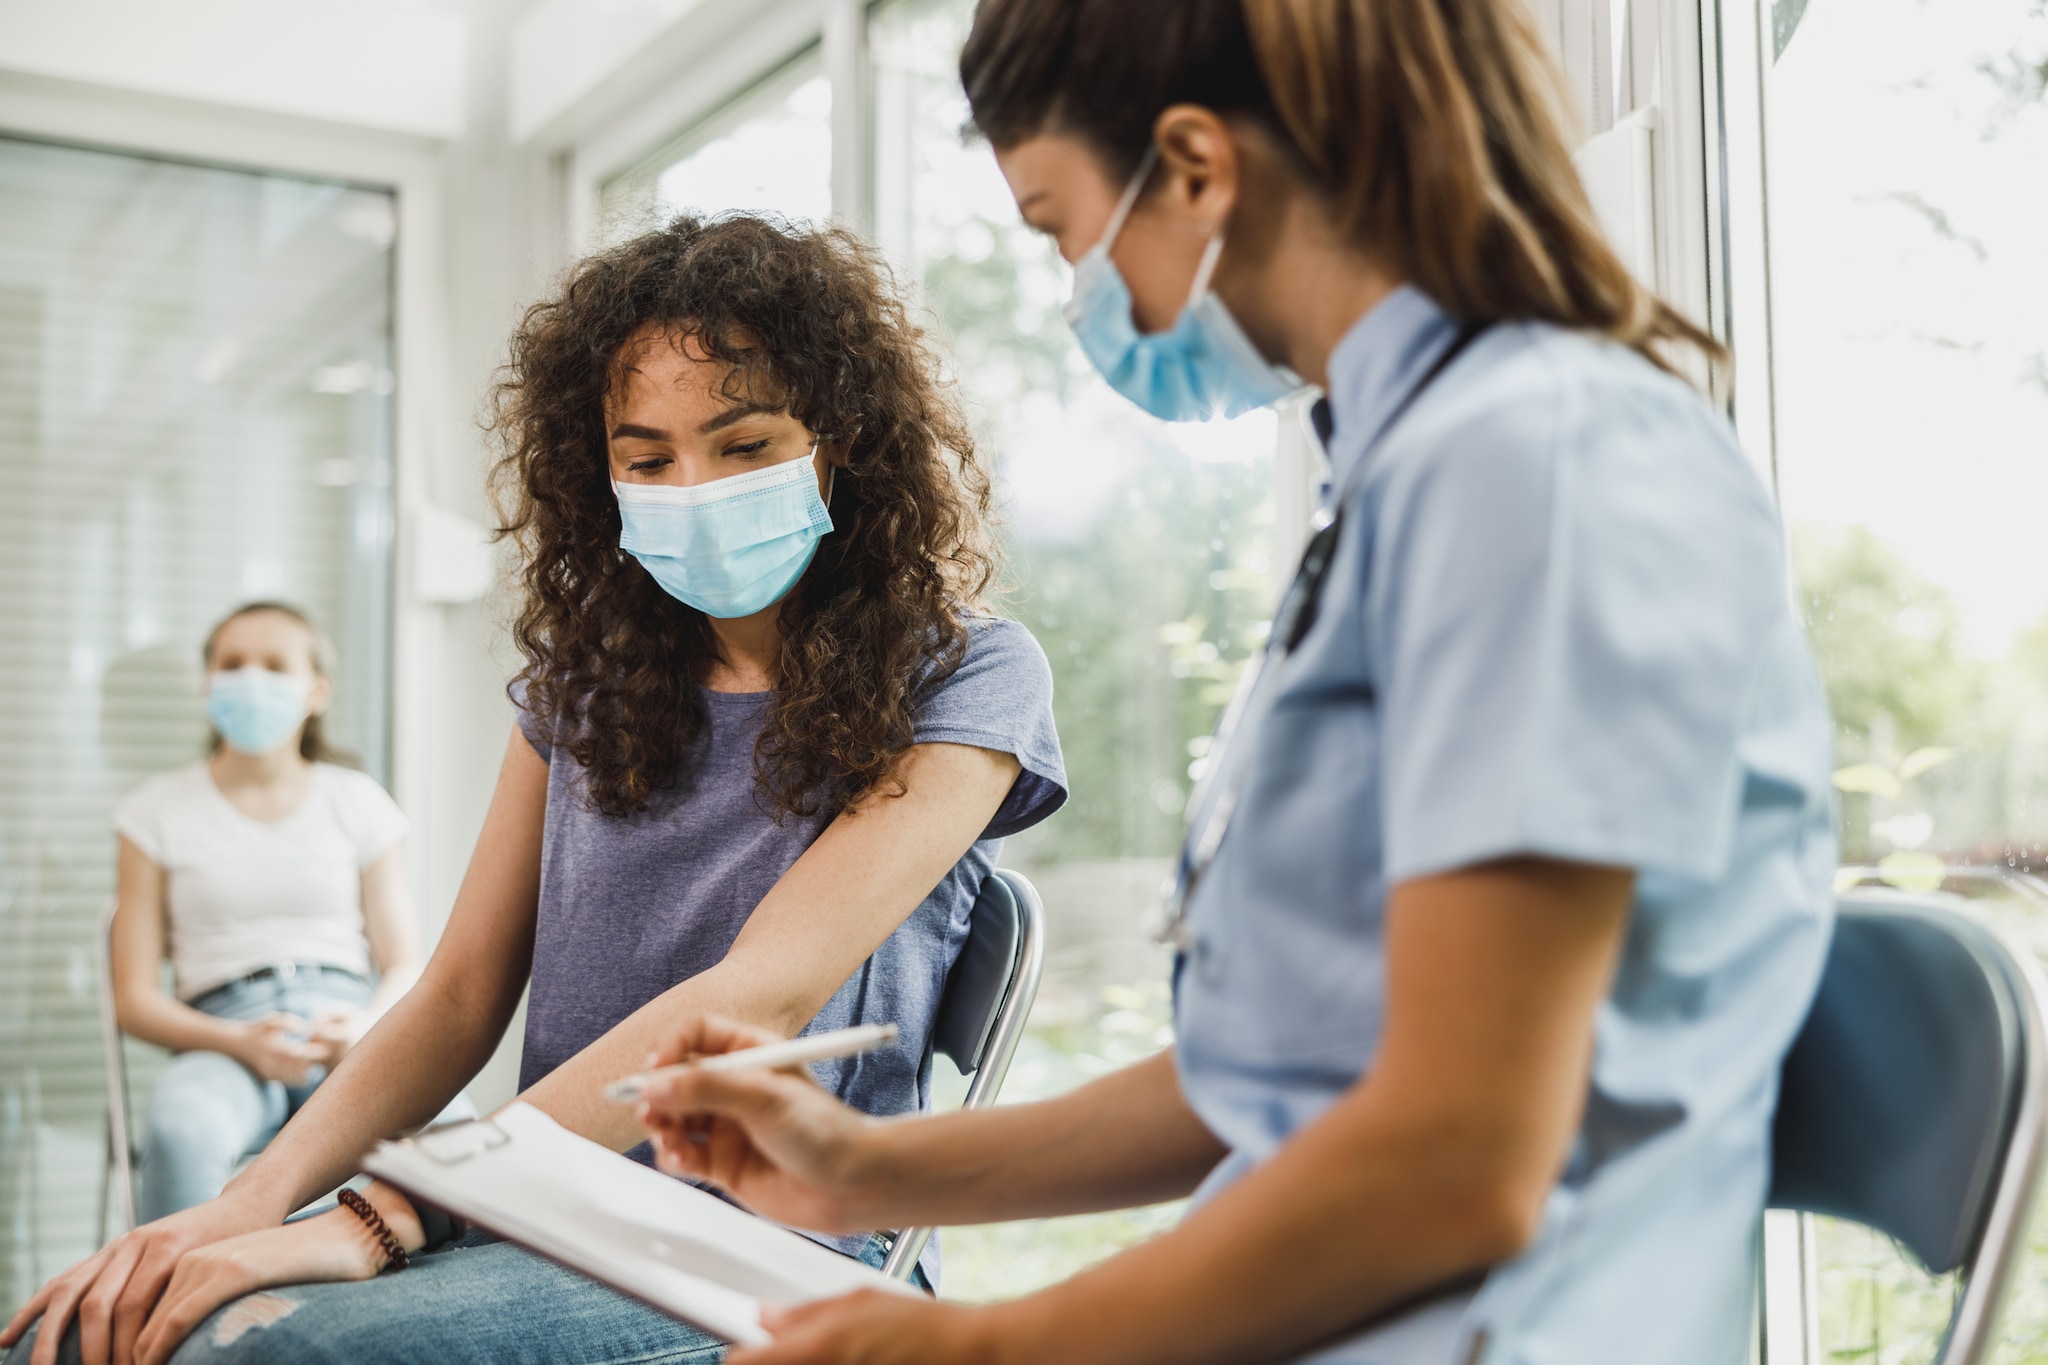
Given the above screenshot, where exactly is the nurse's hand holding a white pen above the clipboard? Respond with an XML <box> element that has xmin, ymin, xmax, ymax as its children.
<box><xmin>641</xmin><ymin>1015</ymin><xmax>889</xmax><ymax>1232</ymax></box>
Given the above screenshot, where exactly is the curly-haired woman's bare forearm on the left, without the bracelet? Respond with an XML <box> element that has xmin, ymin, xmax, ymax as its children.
<box><xmin>229</xmin><ymin>976</ymin><xmax>512</xmax><ymax>1216</ymax></box>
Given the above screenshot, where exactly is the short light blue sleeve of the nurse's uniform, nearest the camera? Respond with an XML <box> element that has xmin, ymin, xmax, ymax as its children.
<box><xmin>1364</xmin><ymin>351</ymin><xmax>1790</xmax><ymax>882</ymax></box>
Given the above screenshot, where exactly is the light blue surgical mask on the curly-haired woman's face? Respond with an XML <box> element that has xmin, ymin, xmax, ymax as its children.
<box><xmin>612</xmin><ymin>444</ymin><xmax>831</xmax><ymax>620</ymax></box>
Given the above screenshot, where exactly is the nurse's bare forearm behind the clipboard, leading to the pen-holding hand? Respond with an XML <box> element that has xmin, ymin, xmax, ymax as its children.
<box><xmin>860</xmin><ymin>1052</ymin><xmax>1225</xmax><ymax>1226</ymax></box>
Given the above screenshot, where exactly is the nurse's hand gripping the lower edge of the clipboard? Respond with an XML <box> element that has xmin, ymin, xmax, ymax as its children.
<box><xmin>725</xmin><ymin>1289</ymin><xmax>1004</xmax><ymax>1365</ymax></box>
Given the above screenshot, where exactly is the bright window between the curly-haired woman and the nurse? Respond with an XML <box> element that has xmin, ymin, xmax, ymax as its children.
<box><xmin>868</xmin><ymin>0</ymin><xmax>1276</xmax><ymax>1297</ymax></box>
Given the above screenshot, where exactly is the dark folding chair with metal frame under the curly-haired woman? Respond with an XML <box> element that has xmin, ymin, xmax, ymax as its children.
<box><xmin>883</xmin><ymin>868</ymin><xmax>1044</xmax><ymax>1279</ymax></box>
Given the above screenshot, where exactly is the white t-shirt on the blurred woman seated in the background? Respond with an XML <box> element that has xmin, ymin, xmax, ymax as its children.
<box><xmin>115</xmin><ymin>761</ymin><xmax>406</xmax><ymax>1001</ymax></box>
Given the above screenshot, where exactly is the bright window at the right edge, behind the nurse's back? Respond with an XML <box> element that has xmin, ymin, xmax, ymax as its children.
<box><xmin>1737</xmin><ymin>0</ymin><xmax>2048</xmax><ymax>1365</ymax></box>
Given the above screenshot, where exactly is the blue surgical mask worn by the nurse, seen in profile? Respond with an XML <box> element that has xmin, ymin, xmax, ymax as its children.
<box><xmin>1065</xmin><ymin>147</ymin><xmax>1303</xmax><ymax>422</ymax></box>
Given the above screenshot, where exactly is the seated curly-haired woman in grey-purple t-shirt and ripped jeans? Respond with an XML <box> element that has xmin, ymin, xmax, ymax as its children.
<box><xmin>8</xmin><ymin>215</ymin><xmax>1065</xmax><ymax>1365</ymax></box>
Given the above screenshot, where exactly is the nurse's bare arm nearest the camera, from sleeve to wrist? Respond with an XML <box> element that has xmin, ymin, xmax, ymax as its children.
<box><xmin>970</xmin><ymin>860</ymin><xmax>1634</xmax><ymax>1365</ymax></box>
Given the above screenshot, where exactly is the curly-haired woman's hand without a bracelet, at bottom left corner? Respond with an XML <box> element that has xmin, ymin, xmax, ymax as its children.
<box><xmin>0</xmin><ymin>1193</ymin><xmax>279</xmax><ymax>1365</ymax></box>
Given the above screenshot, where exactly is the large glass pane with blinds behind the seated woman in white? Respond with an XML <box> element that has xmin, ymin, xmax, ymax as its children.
<box><xmin>0</xmin><ymin>139</ymin><xmax>395</xmax><ymax>1314</ymax></box>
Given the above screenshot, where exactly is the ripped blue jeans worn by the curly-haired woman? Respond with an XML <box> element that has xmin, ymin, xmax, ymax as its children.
<box><xmin>6</xmin><ymin>1232</ymin><xmax>924</xmax><ymax>1365</ymax></box>
